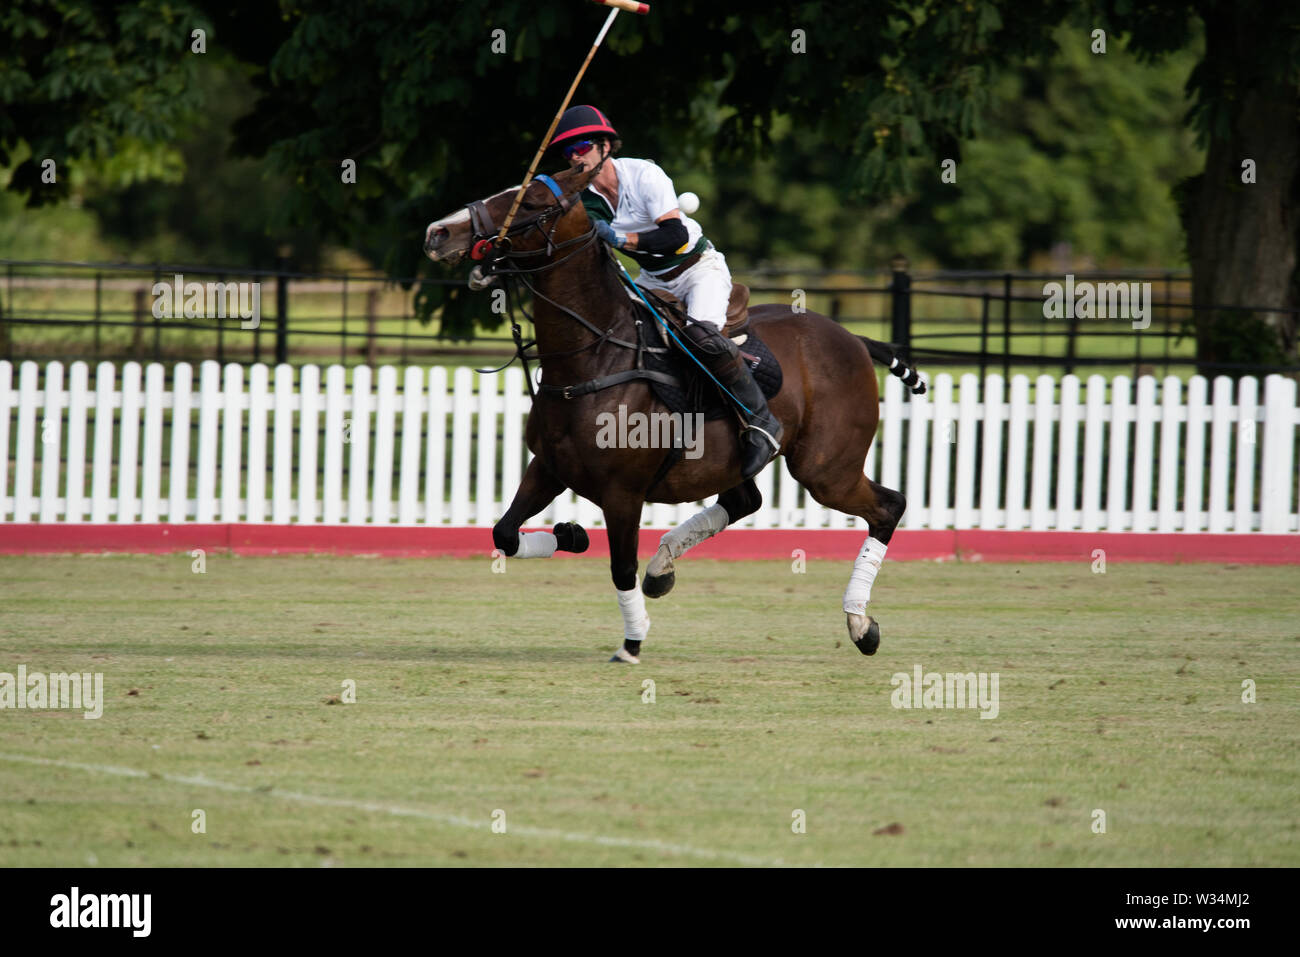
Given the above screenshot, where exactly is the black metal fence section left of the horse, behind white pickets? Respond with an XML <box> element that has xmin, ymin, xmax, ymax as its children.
<box><xmin>0</xmin><ymin>260</ymin><xmax>488</xmax><ymax>364</ymax></box>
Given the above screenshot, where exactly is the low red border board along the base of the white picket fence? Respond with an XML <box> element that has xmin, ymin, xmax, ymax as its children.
<box><xmin>0</xmin><ymin>523</ymin><xmax>1300</xmax><ymax>564</ymax></box>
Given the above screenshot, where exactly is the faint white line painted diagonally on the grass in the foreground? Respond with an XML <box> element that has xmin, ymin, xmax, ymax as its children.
<box><xmin>0</xmin><ymin>752</ymin><xmax>785</xmax><ymax>867</ymax></box>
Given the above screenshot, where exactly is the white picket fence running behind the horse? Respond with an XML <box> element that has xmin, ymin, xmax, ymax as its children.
<box><xmin>0</xmin><ymin>361</ymin><xmax>1300</xmax><ymax>536</ymax></box>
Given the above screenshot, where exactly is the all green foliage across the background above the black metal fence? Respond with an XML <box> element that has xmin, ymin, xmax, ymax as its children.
<box><xmin>0</xmin><ymin>0</ymin><xmax>1300</xmax><ymax>351</ymax></box>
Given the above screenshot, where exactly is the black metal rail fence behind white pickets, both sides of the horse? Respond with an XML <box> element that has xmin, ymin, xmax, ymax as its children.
<box><xmin>0</xmin><ymin>257</ymin><xmax>1300</xmax><ymax>377</ymax></box>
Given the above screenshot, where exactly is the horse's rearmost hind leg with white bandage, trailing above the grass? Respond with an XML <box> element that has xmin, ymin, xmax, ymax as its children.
<box><xmin>796</xmin><ymin>472</ymin><xmax>907</xmax><ymax>655</ymax></box>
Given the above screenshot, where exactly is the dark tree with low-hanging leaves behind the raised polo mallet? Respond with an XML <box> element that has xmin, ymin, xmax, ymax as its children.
<box><xmin>200</xmin><ymin>0</ymin><xmax>1086</xmax><ymax>333</ymax></box>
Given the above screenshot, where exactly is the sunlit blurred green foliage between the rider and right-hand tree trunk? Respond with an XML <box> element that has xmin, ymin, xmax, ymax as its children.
<box><xmin>686</xmin><ymin>26</ymin><xmax>1203</xmax><ymax>269</ymax></box>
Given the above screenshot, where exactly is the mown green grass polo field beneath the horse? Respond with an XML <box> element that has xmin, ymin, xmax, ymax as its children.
<box><xmin>0</xmin><ymin>554</ymin><xmax>1300</xmax><ymax>866</ymax></box>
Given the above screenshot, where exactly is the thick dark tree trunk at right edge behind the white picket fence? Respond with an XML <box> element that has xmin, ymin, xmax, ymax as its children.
<box><xmin>1182</xmin><ymin>4</ymin><xmax>1300</xmax><ymax>374</ymax></box>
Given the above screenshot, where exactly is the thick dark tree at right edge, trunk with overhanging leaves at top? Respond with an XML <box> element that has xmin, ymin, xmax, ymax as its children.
<box><xmin>1102</xmin><ymin>0</ymin><xmax>1300</xmax><ymax>372</ymax></box>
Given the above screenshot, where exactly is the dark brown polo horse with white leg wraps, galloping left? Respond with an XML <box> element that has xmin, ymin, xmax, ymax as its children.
<box><xmin>424</xmin><ymin>164</ymin><xmax>924</xmax><ymax>663</ymax></box>
